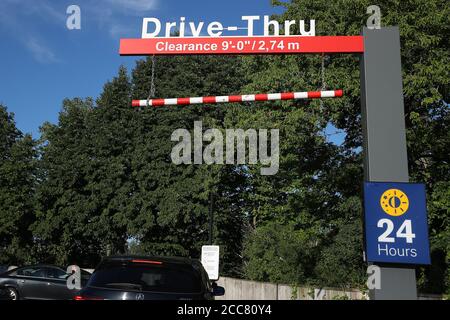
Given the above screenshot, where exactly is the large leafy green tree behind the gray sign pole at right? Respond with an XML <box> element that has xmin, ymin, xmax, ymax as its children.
<box><xmin>241</xmin><ymin>0</ymin><xmax>450</xmax><ymax>292</ymax></box>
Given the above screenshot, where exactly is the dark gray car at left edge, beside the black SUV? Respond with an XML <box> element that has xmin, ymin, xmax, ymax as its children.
<box><xmin>0</xmin><ymin>265</ymin><xmax>90</xmax><ymax>300</ymax></box>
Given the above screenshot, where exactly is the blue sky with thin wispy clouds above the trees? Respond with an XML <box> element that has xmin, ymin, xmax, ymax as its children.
<box><xmin>0</xmin><ymin>0</ymin><xmax>344</xmax><ymax>144</ymax></box>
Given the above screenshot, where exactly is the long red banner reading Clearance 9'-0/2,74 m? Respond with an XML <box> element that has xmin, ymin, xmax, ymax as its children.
<box><xmin>120</xmin><ymin>36</ymin><xmax>364</xmax><ymax>56</ymax></box>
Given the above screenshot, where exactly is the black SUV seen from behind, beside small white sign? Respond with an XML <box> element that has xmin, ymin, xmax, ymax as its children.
<box><xmin>74</xmin><ymin>256</ymin><xmax>229</xmax><ymax>300</ymax></box>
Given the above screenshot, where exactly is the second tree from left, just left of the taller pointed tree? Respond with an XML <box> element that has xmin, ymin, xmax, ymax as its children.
<box><xmin>33</xmin><ymin>99</ymin><xmax>100</xmax><ymax>265</ymax></box>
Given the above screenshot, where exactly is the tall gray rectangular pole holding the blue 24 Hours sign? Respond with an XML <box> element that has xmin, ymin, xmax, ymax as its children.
<box><xmin>360</xmin><ymin>27</ymin><xmax>417</xmax><ymax>300</ymax></box>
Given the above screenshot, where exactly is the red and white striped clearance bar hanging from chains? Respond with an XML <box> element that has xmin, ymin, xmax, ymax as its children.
<box><xmin>132</xmin><ymin>90</ymin><xmax>343</xmax><ymax>107</ymax></box>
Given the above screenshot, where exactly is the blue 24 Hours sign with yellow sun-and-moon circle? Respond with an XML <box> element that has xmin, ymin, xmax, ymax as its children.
<box><xmin>364</xmin><ymin>182</ymin><xmax>430</xmax><ymax>264</ymax></box>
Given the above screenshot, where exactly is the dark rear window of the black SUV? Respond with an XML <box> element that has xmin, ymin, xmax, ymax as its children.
<box><xmin>89</xmin><ymin>264</ymin><xmax>201</xmax><ymax>293</ymax></box>
